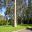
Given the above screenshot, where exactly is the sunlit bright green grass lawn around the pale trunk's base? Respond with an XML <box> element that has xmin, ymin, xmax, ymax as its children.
<box><xmin>0</xmin><ymin>25</ymin><xmax>32</xmax><ymax>32</ymax></box>
